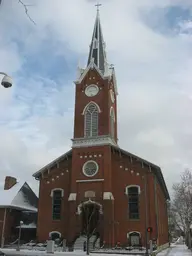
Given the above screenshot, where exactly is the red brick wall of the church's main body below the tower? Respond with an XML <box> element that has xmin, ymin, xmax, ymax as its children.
<box><xmin>37</xmin><ymin>146</ymin><xmax>168</xmax><ymax>245</ymax></box>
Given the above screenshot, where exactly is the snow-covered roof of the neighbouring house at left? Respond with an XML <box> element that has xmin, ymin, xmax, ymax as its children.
<box><xmin>0</xmin><ymin>182</ymin><xmax>37</xmax><ymax>211</ymax></box>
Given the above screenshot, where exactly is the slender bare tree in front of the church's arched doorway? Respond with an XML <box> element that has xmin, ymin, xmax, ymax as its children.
<box><xmin>81</xmin><ymin>200</ymin><xmax>100</xmax><ymax>255</ymax></box>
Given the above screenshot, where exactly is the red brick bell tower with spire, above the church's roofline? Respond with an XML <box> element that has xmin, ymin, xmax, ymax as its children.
<box><xmin>72</xmin><ymin>5</ymin><xmax>117</xmax><ymax>148</ymax></box>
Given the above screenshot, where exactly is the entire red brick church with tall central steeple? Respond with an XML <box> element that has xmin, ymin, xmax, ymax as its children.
<box><xmin>33</xmin><ymin>8</ymin><xmax>169</xmax><ymax>250</ymax></box>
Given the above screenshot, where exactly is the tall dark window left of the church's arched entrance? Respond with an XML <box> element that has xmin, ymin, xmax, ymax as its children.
<box><xmin>52</xmin><ymin>190</ymin><xmax>62</xmax><ymax>220</ymax></box>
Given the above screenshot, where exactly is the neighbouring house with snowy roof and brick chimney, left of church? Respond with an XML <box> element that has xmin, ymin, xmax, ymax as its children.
<box><xmin>0</xmin><ymin>176</ymin><xmax>38</xmax><ymax>247</ymax></box>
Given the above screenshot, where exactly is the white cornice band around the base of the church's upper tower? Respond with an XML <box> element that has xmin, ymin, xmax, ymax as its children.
<box><xmin>72</xmin><ymin>135</ymin><xmax>117</xmax><ymax>148</ymax></box>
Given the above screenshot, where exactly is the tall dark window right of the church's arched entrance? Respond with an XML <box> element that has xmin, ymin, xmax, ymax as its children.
<box><xmin>127</xmin><ymin>186</ymin><xmax>139</xmax><ymax>219</ymax></box>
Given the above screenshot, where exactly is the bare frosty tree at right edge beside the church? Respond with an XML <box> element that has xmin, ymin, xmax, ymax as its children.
<box><xmin>171</xmin><ymin>169</ymin><xmax>192</xmax><ymax>248</ymax></box>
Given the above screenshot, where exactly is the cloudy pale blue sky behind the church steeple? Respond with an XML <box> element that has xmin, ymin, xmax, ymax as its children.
<box><xmin>0</xmin><ymin>0</ymin><xmax>192</xmax><ymax>196</ymax></box>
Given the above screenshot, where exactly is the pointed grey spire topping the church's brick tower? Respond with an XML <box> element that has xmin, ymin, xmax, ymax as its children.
<box><xmin>87</xmin><ymin>4</ymin><xmax>107</xmax><ymax>74</ymax></box>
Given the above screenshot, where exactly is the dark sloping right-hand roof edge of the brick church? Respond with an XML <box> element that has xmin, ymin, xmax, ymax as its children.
<box><xmin>111</xmin><ymin>146</ymin><xmax>170</xmax><ymax>200</ymax></box>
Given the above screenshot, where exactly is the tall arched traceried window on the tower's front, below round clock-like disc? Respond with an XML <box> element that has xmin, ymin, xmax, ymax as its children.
<box><xmin>84</xmin><ymin>103</ymin><xmax>99</xmax><ymax>137</ymax></box>
